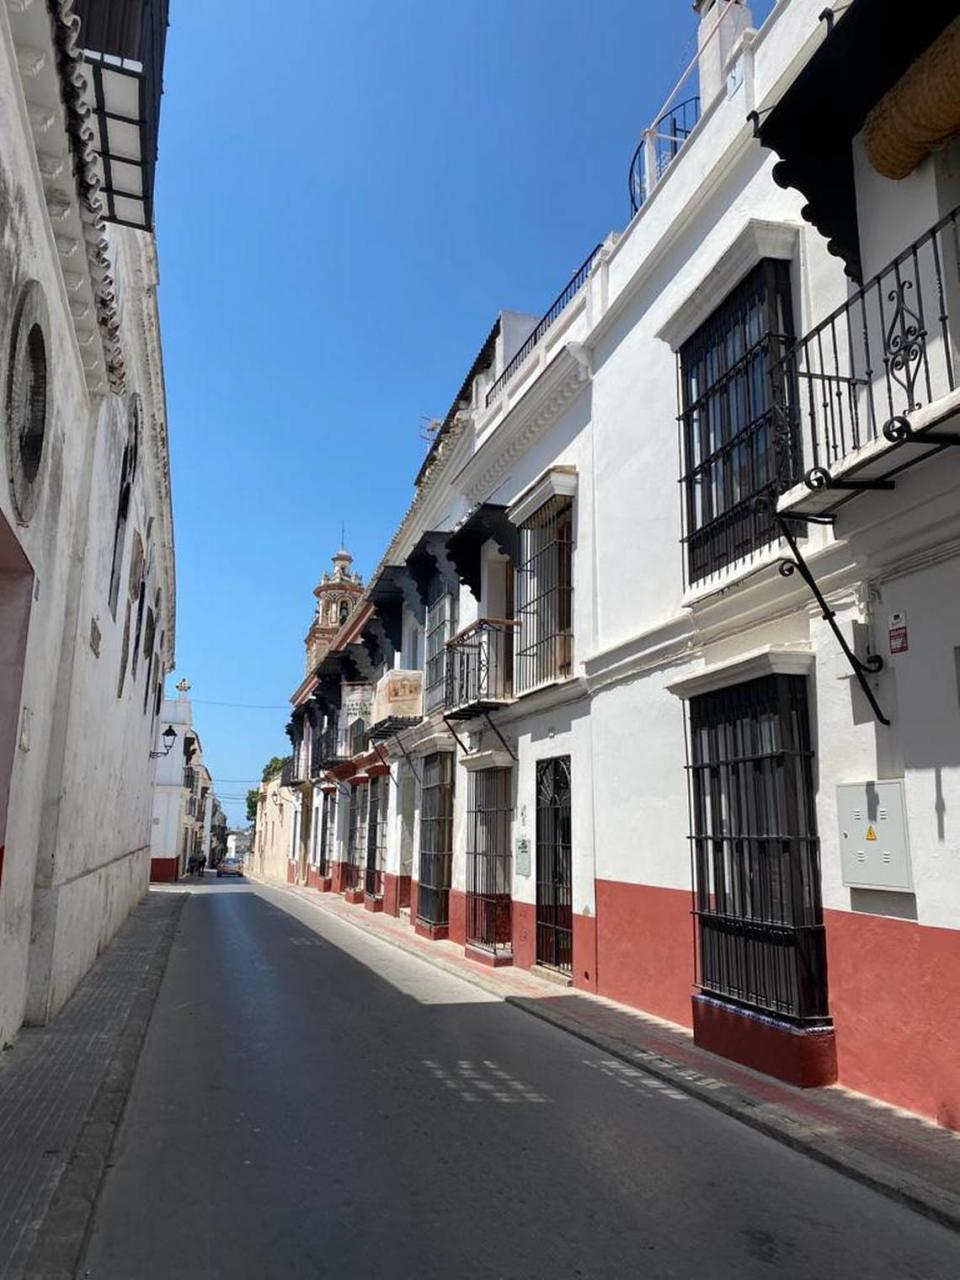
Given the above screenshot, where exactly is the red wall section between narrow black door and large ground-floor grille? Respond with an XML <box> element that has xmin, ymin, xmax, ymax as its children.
<box><xmin>599</xmin><ymin>881</ymin><xmax>694</xmax><ymax>1027</ymax></box>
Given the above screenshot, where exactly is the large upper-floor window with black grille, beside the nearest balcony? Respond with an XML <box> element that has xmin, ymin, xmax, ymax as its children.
<box><xmin>680</xmin><ymin>259</ymin><xmax>801</xmax><ymax>584</ymax></box>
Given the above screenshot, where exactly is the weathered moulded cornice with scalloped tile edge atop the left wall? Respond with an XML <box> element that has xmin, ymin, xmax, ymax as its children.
<box><xmin>6</xmin><ymin>0</ymin><xmax>125</xmax><ymax>396</ymax></box>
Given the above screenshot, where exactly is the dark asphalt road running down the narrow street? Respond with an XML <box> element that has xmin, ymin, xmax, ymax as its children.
<box><xmin>79</xmin><ymin>881</ymin><xmax>960</xmax><ymax>1280</ymax></box>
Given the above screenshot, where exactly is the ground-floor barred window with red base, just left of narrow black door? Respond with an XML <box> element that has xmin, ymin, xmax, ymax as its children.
<box><xmin>467</xmin><ymin>769</ymin><xmax>513</xmax><ymax>954</ymax></box>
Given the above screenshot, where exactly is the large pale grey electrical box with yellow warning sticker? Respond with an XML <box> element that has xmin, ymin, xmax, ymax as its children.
<box><xmin>837</xmin><ymin>782</ymin><xmax>914</xmax><ymax>891</ymax></box>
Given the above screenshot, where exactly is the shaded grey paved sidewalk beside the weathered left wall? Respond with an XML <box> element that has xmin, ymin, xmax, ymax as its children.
<box><xmin>0</xmin><ymin>892</ymin><xmax>187</xmax><ymax>1280</ymax></box>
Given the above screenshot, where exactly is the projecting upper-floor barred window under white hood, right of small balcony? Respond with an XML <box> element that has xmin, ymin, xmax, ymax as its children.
<box><xmin>513</xmin><ymin>497</ymin><xmax>573</xmax><ymax>694</ymax></box>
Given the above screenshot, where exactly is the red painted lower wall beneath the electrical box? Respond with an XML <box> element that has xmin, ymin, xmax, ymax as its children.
<box><xmin>824</xmin><ymin>911</ymin><xmax>960</xmax><ymax>1129</ymax></box>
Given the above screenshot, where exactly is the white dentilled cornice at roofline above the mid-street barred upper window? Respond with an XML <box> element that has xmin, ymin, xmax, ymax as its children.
<box><xmin>456</xmin><ymin>342</ymin><xmax>591</xmax><ymax>503</ymax></box>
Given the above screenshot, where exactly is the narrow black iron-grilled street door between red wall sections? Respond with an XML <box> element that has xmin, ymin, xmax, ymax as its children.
<box><xmin>536</xmin><ymin>755</ymin><xmax>573</xmax><ymax>973</ymax></box>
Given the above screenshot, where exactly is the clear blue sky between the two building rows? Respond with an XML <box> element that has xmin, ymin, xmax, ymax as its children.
<box><xmin>156</xmin><ymin>0</ymin><xmax>772</xmax><ymax>822</ymax></box>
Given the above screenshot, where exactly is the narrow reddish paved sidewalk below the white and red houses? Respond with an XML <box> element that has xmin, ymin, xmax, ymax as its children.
<box><xmin>261</xmin><ymin>881</ymin><xmax>960</xmax><ymax>1230</ymax></box>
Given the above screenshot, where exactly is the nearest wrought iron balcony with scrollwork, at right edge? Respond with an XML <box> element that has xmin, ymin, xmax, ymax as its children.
<box><xmin>772</xmin><ymin>210</ymin><xmax>960</xmax><ymax>516</ymax></box>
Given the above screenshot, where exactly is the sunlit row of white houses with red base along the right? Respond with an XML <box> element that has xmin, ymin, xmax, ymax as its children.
<box><xmin>280</xmin><ymin>0</ymin><xmax>960</xmax><ymax>1126</ymax></box>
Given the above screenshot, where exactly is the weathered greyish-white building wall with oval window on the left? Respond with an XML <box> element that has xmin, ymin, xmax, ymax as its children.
<box><xmin>0</xmin><ymin>0</ymin><xmax>174</xmax><ymax>1039</ymax></box>
